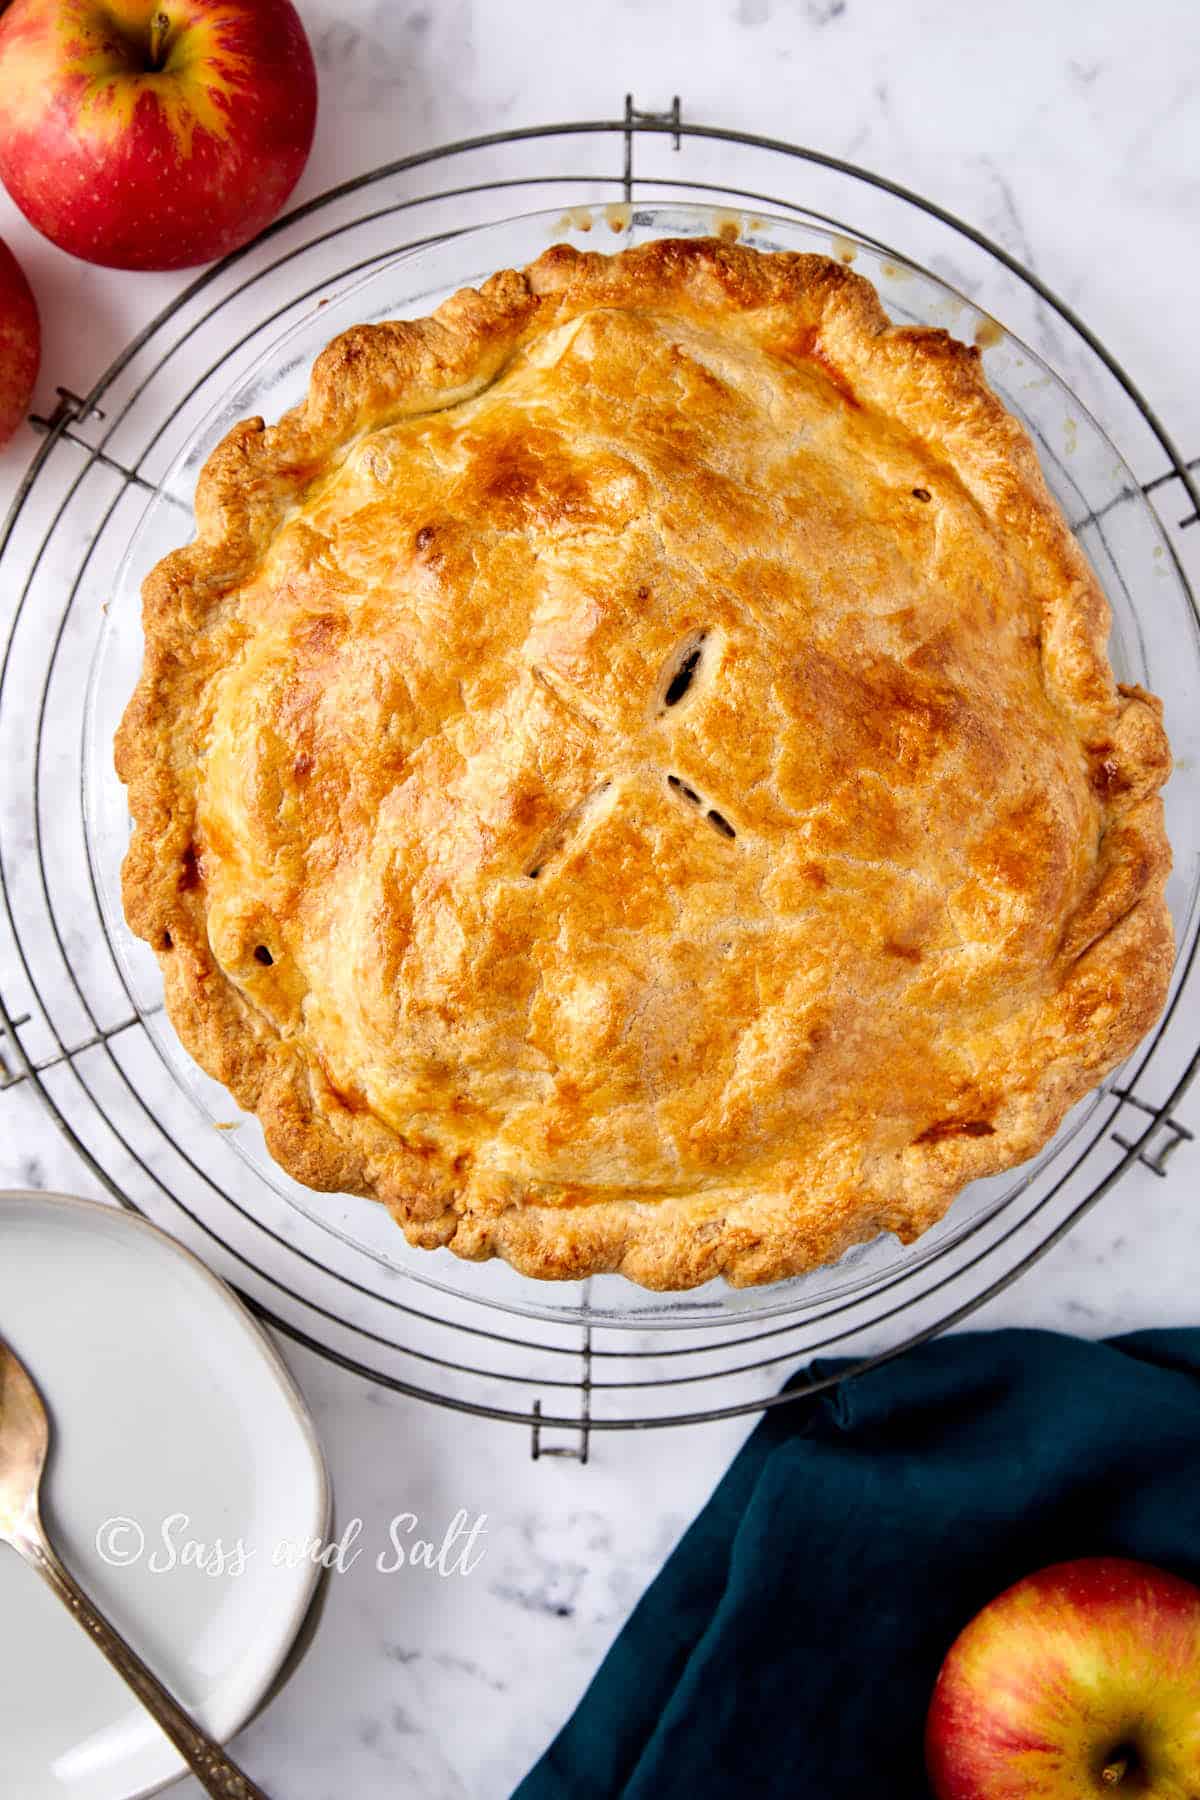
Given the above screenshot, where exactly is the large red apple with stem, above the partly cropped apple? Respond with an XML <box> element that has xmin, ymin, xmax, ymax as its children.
<box><xmin>0</xmin><ymin>0</ymin><xmax>317</xmax><ymax>268</ymax></box>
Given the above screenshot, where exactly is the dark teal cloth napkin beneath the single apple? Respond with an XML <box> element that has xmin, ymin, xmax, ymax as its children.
<box><xmin>516</xmin><ymin>1330</ymin><xmax>1200</xmax><ymax>1800</ymax></box>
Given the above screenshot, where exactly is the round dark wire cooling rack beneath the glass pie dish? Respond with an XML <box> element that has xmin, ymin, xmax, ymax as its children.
<box><xmin>0</xmin><ymin>99</ymin><xmax>1200</xmax><ymax>1462</ymax></box>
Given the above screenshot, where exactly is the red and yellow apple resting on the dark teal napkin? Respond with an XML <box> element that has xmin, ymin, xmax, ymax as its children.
<box><xmin>925</xmin><ymin>1557</ymin><xmax>1200</xmax><ymax>1800</ymax></box>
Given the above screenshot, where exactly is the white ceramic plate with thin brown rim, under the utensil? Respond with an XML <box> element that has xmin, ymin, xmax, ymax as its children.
<box><xmin>0</xmin><ymin>1193</ymin><xmax>329</xmax><ymax>1800</ymax></box>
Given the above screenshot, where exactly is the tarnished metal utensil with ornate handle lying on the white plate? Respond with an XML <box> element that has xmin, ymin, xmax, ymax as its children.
<box><xmin>0</xmin><ymin>1337</ymin><xmax>266</xmax><ymax>1800</ymax></box>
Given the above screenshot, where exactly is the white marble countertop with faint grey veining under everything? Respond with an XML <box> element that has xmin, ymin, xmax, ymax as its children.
<box><xmin>0</xmin><ymin>0</ymin><xmax>1200</xmax><ymax>1800</ymax></box>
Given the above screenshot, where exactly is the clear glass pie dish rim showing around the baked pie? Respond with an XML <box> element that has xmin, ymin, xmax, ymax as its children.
<box><xmin>83</xmin><ymin>202</ymin><xmax>1200</xmax><ymax>1328</ymax></box>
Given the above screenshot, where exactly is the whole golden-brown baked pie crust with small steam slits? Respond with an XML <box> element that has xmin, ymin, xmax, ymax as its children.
<box><xmin>117</xmin><ymin>239</ymin><xmax>1171</xmax><ymax>1289</ymax></box>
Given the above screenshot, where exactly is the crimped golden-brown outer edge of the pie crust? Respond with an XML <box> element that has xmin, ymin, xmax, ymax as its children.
<box><xmin>117</xmin><ymin>239</ymin><xmax>1173</xmax><ymax>1289</ymax></box>
